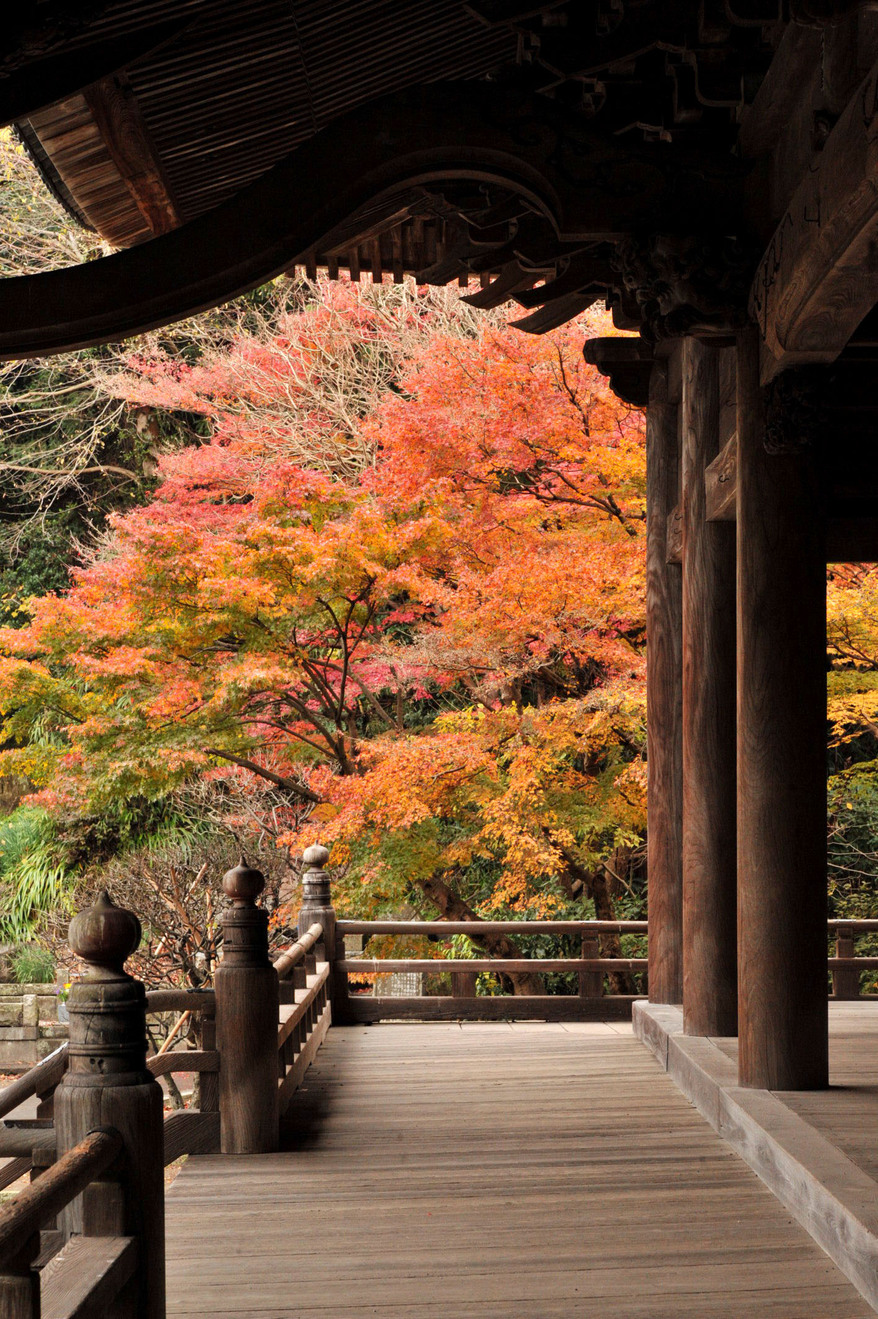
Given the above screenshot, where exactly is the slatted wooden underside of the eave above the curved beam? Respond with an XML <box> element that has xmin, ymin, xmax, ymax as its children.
<box><xmin>16</xmin><ymin>0</ymin><xmax>515</xmax><ymax>267</ymax></box>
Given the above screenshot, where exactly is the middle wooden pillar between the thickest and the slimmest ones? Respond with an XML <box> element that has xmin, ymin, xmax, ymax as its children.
<box><xmin>683</xmin><ymin>339</ymin><xmax>738</xmax><ymax>1035</ymax></box>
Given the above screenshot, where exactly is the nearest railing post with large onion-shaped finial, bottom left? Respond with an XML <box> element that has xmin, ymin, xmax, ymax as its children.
<box><xmin>55</xmin><ymin>893</ymin><xmax>165</xmax><ymax>1319</ymax></box>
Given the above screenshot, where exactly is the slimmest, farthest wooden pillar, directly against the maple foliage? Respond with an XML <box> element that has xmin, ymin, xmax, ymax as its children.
<box><xmin>646</xmin><ymin>361</ymin><xmax>683</xmax><ymax>1002</ymax></box>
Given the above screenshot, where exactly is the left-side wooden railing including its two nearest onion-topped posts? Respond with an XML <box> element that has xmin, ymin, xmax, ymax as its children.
<box><xmin>0</xmin><ymin>852</ymin><xmax>334</xmax><ymax>1319</ymax></box>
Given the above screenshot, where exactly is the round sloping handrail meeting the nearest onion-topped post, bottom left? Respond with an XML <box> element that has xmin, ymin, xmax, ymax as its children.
<box><xmin>0</xmin><ymin>1126</ymin><xmax>124</xmax><ymax>1270</ymax></box>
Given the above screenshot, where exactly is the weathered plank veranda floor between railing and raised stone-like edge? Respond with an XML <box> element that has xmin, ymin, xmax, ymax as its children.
<box><xmin>167</xmin><ymin>1024</ymin><xmax>873</xmax><ymax>1319</ymax></box>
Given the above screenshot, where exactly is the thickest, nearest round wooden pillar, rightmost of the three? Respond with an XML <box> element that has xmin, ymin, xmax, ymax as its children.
<box><xmin>737</xmin><ymin>328</ymin><xmax>828</xmax><ymax>1089</ymax></box>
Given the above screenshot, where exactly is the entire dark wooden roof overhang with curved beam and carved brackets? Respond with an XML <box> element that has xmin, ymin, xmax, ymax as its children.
<box><xmin>0</xmin><ymin>0</ymin><xmax>878</xmax><ymax>371</ymax></box>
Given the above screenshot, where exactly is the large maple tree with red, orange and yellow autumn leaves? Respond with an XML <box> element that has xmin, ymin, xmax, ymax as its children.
<box><xmin>0</xmin><ymin>285</ymin><xmax>645</xmax><ymax>981</ymax></box>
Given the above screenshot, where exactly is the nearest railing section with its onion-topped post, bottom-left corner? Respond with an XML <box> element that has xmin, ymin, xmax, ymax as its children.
<box><xmin>0</xmin><ymin>894</ymin><xmax>165</xmax><ymax>1319</ymax></box>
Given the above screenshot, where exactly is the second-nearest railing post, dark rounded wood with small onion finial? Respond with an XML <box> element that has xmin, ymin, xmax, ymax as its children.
<box><xmin>214</xmin><ymin>857</ymin><xmax>279</xmax><ymax>1154</ymax></box>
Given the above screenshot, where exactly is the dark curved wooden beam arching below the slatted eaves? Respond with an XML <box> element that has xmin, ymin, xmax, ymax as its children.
<box><xmin>0</xmin><ymin>82</ymin><xmax>740</xmax><ymax>359</ymax></box>
